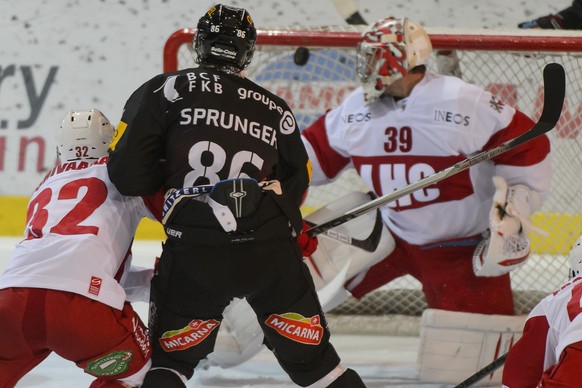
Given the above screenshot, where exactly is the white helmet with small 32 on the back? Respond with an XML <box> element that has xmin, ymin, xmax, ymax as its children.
<box><xmin>56</xmin><ymin>109</ymin><xmax>115</xmax><ymax>162</ymax></box>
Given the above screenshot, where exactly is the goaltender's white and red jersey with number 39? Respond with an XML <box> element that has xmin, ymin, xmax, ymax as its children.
<box><xmin>302</xmin><ymin>73</ymin><xmax>551</xmax><ymax>245</ymax></box>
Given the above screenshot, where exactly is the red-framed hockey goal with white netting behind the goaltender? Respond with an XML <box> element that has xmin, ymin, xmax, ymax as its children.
<box><xmin>164</xmin><ymin>26</ymin><xmax>582</xmax><ymax>334</ymax></box>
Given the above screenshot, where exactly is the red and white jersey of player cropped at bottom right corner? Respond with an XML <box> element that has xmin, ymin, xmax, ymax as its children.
<box><xmin>503</xmin><ymin>277</ymin><xmax>582</xmax><ymax>387</ymax></box>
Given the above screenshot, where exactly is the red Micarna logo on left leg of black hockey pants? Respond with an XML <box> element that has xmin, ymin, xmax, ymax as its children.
<box><xmin>160</xmin><ymin>319</ymin><xmax>220</xmax><ymax>352</ymax></box>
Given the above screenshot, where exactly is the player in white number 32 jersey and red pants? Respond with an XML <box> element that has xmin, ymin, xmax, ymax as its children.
<box><xmin>0</xmin><ymin>109</ymin><xmax>163</xmax><ymax>388</ymax></box>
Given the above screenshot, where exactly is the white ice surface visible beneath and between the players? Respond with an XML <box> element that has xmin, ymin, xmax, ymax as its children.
<box><xmin>0</xmin><ymin>237</ymin><xmax>448</xmax><ymax>388</ymax></box>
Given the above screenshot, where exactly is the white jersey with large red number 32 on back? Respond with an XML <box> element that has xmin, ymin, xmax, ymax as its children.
<box><xmin>0</xmin><ymin>157</ymin><xmax>162</xmax><ymax>310</ymax></box>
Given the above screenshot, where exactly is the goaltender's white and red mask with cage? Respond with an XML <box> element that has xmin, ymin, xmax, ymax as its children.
<box><xmin>356</xmin><ymin>17</ymin><xmax>432</xmax><ymax>103</ymax></box>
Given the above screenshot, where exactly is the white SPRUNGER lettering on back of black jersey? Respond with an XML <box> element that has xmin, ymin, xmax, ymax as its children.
<box><xmin>180</xmin><ymin>108</ymin><xmax>277</xmax><ymax>147</ymax></box>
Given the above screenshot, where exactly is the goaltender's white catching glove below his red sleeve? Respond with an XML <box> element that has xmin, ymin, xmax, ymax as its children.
<box><xmin>473</xmin><ymin>176</ymin><xmax>541</xmax><ymax>276</ymax></box>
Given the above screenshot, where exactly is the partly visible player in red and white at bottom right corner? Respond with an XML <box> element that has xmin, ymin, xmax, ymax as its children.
<box><xmin>503</xmin><ymin>236</ymin><xmax>582</xmax><ymax>388</ymax></box>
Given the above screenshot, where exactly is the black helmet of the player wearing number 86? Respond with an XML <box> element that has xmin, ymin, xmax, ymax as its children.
<box><xmin>194</xmin><ymin>4</ymin><xmax>257</xmax><ymax>70</ymax></box>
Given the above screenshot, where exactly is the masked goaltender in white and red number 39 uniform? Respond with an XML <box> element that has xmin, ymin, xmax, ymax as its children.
<box><xmin>209</xmin><ymin>14</ymin><xmax>551</xmax><ymax>385</ymax></box>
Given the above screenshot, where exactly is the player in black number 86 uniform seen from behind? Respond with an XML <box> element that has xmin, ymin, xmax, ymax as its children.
<box><xmin>108</xmin><ymin>5</ymin><xmax>365</xmax><ymax>388</ymax></box>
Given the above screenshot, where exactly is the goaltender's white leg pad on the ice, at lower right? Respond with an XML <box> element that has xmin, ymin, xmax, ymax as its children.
<box><xmin>417</xmin><ymin>309</ymin><xmax>526</xmax><ymax>386</ymax></box>
